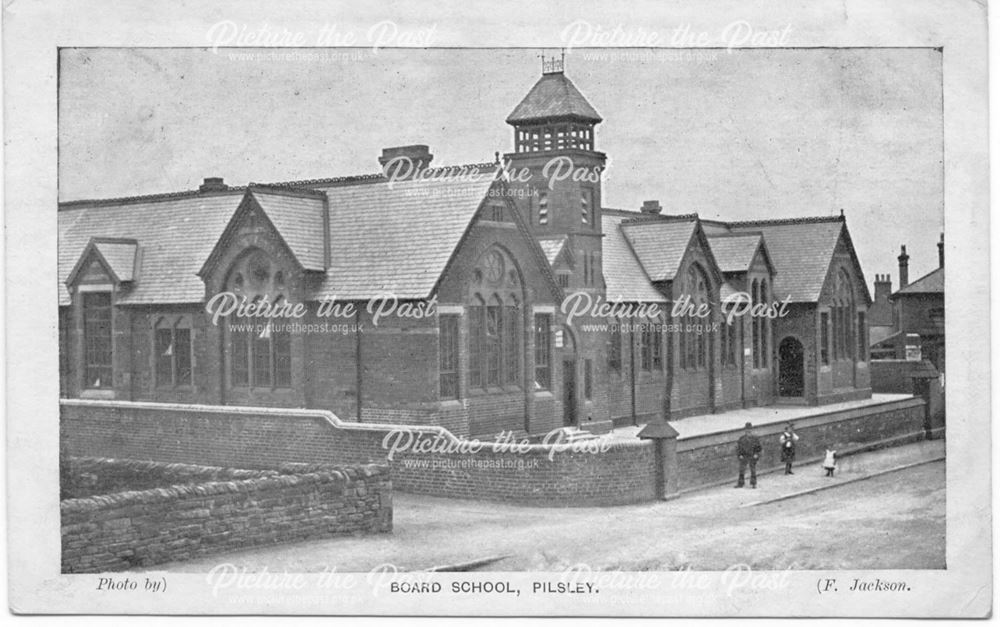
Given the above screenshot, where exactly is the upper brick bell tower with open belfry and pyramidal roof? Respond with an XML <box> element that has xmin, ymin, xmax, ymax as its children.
<box><xmin>505</xmin><ymin>55</ymin><xmax>606</xmax><ymax>293</ymax></box>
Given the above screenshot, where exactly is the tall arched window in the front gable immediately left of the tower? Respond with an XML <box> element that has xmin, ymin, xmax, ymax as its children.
<box><xmin>468</xmin><ymin>248</ymin><xmax>523</xmax><ymax>389</ymax></box>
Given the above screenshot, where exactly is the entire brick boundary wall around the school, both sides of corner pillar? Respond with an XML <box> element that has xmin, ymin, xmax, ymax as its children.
<box><xmin>61</xmin><ymin>399</ymin><xmax>923</xmax><ymax>507</ymax></box>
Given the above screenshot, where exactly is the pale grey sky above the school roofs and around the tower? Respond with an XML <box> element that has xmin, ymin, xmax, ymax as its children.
<box><xmin>59</xmin><ymin>48</ymin><xmax>944</xmax><ymax>289</ymax></box>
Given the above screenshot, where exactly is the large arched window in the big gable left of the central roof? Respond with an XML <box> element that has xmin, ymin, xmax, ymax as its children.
<box><xmin>227</xmin><ymin>250</ymin><xmax>292</xmax><ymax>388</ymax></box>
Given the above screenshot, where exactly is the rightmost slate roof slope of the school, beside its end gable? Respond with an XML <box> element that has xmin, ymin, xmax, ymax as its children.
<box><xmin>730</xmin><ymin>217</ymin><xmax>844</xmax><ymax>303</ymax></box>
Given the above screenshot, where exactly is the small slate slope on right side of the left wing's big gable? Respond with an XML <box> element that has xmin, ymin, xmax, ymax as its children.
<box><xmin>250</xmin><ymin>186</ymin><xmax>326</xmax><ymax>271</ymax></box>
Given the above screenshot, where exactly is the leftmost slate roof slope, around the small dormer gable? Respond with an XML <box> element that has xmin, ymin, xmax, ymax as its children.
<box><xmin>58</xmin><ymin>193</ymin><xmax>242</xmax><ymax>305</ymax></box>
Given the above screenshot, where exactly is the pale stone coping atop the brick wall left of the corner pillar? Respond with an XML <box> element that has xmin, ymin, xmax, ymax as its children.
<box><xmin>59</xmin><ymin>398</ymin><xmax>648</xmax><ymax>454</ymax></box>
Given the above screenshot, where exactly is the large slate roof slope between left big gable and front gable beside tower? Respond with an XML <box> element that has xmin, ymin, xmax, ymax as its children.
<box><xmin>316</xmin><ymin>165</ymin><xmax>499</xmax><ymax>300</ymax></box>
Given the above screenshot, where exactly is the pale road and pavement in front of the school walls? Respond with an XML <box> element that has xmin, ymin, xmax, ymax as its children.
<box><xmin>152</xmin><ymin>440</ymin><xmax>945</xmax><ymax>573</ymax></box>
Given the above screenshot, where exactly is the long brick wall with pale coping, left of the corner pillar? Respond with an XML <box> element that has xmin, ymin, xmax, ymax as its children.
<box><xmin>61</xmin><ymin>399</ymin><xmax>655</xmax><ymax>506</ymax></box>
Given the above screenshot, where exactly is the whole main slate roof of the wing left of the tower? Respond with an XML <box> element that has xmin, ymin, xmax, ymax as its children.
<box><xmin>59</xmin><ymin>164</ymin><xmax>497</xmax><ymax>305</ymax></box>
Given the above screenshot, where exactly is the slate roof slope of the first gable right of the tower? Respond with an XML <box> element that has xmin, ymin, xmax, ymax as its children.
<box><xmin>621</xmin><ymin>215</ymin><xmax>698</xmax><ymax>281</ymax></box>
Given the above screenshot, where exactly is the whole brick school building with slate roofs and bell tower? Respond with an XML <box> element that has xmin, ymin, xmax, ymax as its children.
<box><xmin>59</xmin><ymin>61</ymin><xmax>871</xmax><ymax>435</ymax></box>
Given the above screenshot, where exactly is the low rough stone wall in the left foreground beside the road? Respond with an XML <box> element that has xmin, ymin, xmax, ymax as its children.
<box><xmin>60</xmin><ymin>456</ymin><xmax>392</xmax><ymax>573</ymax></box>
